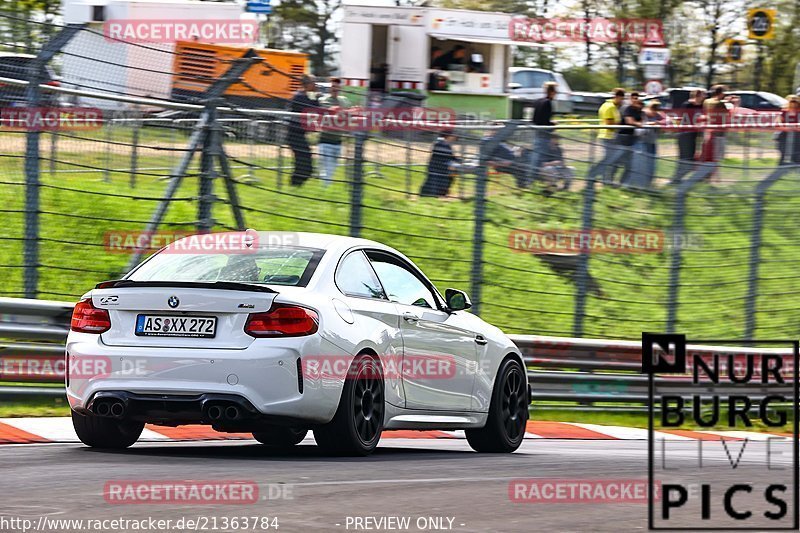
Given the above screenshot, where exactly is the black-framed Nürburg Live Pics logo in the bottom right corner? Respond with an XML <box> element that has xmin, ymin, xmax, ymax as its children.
<box><xmin>642</xmin><ymin>333</ymin><xmax>800</xmax><ymax>531</ymax></box>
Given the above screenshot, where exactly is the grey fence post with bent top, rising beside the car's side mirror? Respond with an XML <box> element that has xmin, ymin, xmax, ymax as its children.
<box><xmin>470</xmin><ymin>120</ymin><xmax>520</xmax><ymax>316</ymax></box>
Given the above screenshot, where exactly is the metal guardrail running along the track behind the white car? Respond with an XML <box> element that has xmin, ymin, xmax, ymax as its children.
<box><xmin>0</xmin><ymin>298</ymin><xmax>794</xmax><ymax>410</ymax></box>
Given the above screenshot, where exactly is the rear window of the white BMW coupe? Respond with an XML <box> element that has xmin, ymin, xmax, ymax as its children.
<box><xmin>126</xmin><ymin>247</ymin><xmax>324</xmax><ymax>287</ymax></box>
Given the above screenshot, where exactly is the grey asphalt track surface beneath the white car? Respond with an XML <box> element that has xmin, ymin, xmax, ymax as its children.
<box><xmin>0</xmin><ymin>438</ymin><xmax>792</xmax><ymax>532</ymax></box>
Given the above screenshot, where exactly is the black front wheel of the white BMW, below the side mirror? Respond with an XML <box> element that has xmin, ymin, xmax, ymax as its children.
<box><xmin>466</xmin><ymin>359</ymin><xmax>530</xmax><ymax>453</ymax></box>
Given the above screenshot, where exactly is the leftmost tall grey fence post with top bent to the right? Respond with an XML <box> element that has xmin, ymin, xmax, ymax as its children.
<box><xmin>23</xmin><ymin>24</ymin><xmax>84</xmax><ymax>298</ymax></box>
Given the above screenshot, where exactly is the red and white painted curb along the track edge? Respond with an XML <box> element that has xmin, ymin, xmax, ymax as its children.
<box><xmin>0</xmin><ymin>417</ymin><xmax>789</xmax><ymax>444</ymax></box>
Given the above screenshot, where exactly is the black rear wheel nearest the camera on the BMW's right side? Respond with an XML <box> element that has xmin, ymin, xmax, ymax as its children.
<box><xmin>314</xmin><ymin>354</ymin><xmax>385</xmax><ymax>455</ymax></box>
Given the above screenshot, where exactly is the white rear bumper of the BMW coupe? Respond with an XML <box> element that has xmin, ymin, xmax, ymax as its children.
<box><xmin>67</xmin><ymin>332</ymin><xmax>350</xmax><ymax>424</ymax></box>
